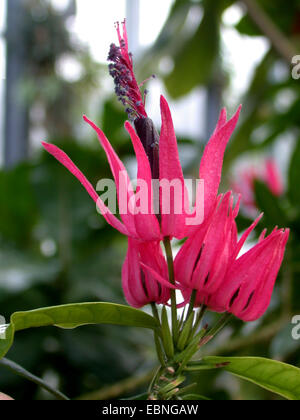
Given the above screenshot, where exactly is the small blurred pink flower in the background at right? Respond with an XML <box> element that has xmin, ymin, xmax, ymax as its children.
<box><xmin>233</xmin><ymin>158</ymin><xmax>284</xmax><ymax>214</ymax></box>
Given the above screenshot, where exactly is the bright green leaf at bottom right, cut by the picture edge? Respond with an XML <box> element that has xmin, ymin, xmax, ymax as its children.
<box><xmin>203</xmin><ymin>357</ymin><xmax>300</xmax><ymax>401</ymax></box>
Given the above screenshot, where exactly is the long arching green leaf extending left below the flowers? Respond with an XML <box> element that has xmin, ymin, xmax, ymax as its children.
<box><xmin>0</xmin><ymin>302</ymin><xmax>159</xmax><ymax>358</ymax></box>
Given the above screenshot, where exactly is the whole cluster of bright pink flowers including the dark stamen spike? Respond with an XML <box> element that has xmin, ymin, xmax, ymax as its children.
<box><xmin>43</xmin><ymin>23</ymin><xmax>289</xmax><ymax>321</ymax></box>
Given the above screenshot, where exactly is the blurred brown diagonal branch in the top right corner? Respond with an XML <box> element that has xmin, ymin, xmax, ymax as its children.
<box><xmin>242</xmin><ymin>0</ymin><xmax>297</xmax><ymax>64</ymax></box>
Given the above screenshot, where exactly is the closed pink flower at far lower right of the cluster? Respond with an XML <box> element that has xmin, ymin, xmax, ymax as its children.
<box><xmin>210</xmin><ymin>229</ymin><xmax>289</xmax><ymax>322</ymax></box>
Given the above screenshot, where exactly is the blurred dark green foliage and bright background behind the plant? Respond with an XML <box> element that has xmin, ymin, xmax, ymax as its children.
<box><xmin>0</xmin><ymin>0</ymin><xmax>300</xmax><ymax>400</ymax></box>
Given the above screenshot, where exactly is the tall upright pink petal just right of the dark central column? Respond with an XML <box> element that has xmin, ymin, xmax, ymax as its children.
<box><xmin>159</xmin><ymin>96</ymin><xmax>188</xmax><ymax>239</ymax></box>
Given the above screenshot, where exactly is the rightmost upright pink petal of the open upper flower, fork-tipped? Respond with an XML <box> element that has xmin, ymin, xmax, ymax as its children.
<box><xmin>199</xmin><ymin>107</ymin><xmax>241</xmax><ymax>217</ymax></box>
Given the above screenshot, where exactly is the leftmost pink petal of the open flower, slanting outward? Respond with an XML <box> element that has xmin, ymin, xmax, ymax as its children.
<box><xmin>42</xmin><ymin>142</ymin><xmax>128</xmax><ymax>235</ymax></box>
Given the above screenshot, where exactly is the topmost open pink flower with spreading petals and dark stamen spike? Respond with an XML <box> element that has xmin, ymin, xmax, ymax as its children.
<box><xmin>43</xmin><ymin>18</ymin><xmax>240</xmax><ymax>241</ymax></box>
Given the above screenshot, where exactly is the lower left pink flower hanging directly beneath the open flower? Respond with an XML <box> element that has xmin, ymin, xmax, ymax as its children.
<box><xmin>122</xmin><ymin>238</ymin><xmax>170</xmax><ymax>308</ymax></box>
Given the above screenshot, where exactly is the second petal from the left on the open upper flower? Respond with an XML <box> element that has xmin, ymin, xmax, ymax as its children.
<box><xmin>83</xmin><ymin>115</ymin><xmax>137</xmax><ymax>237</ymax></box>
